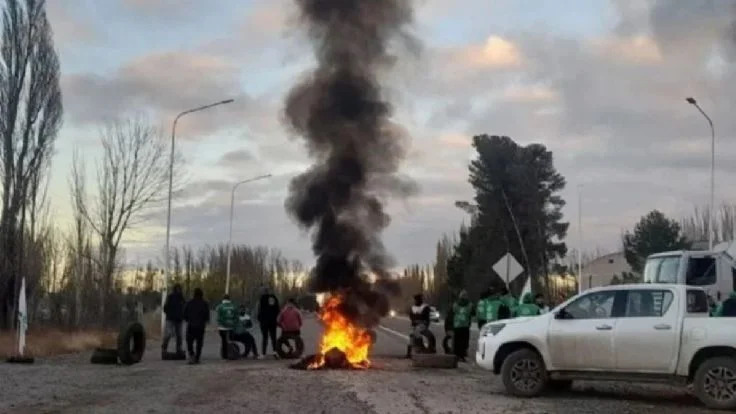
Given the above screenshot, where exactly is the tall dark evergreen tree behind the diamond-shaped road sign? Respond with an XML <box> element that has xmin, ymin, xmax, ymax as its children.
<box><xmin>448</xmin><ymin>135</ymin><xmax>568</xmax><ymax>297</ymax></box>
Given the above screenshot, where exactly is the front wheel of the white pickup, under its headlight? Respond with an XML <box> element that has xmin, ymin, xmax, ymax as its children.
<box><xmin>501</xmin><ymin>348</ymin><xmax>549</xmax><ymax>398</ymax></box>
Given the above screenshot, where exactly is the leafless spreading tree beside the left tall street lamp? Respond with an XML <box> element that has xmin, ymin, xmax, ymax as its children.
<box><xmin>72</xmin><ymin>118</ymin><xmax>168</xmax><ymax>326</ymax></box>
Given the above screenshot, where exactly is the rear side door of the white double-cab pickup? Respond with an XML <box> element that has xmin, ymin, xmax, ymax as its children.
<box><xmin>613</xmin><ymin>289</ymin><xmax>680</xmax><ymax>374</ymax></box>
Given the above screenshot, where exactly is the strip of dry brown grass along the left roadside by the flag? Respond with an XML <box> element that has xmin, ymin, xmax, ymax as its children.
<box><xmin>0</xmin><ymin>329</ymin><xmax>117</xmax><ymax>358</ymax></box>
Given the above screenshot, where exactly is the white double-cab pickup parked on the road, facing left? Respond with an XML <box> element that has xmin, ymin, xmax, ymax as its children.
<box><xmin>475</xmin><ymin>284</ymin><xmax>736</xmax><ymax>409</ymax></box>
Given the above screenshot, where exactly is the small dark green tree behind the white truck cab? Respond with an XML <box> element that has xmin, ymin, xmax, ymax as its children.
<box><xmin>623</xmin><ymin>210</ymin><xmax>690</xmax><ymax>274</ymax></box>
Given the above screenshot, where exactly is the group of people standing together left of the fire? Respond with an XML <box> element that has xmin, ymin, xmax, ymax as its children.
<box><xmin>161</xmin><ymin>284</ymin><xmax>302</xmax><ymax>364</ymax></box>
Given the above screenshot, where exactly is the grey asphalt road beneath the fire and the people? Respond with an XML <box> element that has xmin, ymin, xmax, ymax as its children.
<box><xmin>0</xmin><ymin>317</ymin><xmax>720</xmax><ymax>414</ymax></box>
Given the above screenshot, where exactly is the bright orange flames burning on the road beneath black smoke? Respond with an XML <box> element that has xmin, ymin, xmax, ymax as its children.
<box><xmin>309</xmin><ymin>295</ymin><xmax>372</xmax><ymax>369</ymax></box>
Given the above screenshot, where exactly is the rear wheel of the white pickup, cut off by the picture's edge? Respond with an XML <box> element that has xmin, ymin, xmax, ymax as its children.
<box><xmin>693</xmin><ymin>357</ymin><xmax>736</xmax><ymax>410</ymax></box>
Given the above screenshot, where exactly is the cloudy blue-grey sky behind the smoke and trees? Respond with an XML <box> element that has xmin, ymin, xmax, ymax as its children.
<box><xmin>48</xmin><ymin>0</ymin><xmax>736</xmax><ymax>265</ymax></box>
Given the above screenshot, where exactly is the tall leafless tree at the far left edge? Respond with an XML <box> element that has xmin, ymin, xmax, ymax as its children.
<box><xmin>0</xmin><ymin>0</ymin><xmax>63</xmax><ymax>328</ymax></box>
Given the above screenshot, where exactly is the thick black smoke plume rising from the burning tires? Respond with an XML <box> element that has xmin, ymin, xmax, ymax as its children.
<box><xmin>285</xmin><ymin>0</ymin><xmax>413</xmax><ymax>327</ymax></box>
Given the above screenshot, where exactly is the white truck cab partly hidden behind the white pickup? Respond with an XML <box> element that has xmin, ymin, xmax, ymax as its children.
<box><xmin>644</xmin><ymin>241</ymin><xmax>736</xmax><ymax>302</ymax></box>
